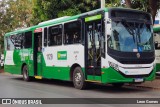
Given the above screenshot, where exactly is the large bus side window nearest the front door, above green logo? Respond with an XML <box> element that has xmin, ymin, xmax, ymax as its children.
<box><xmin>64</xmin><ymin>21</ymin><xmax>81</xmax><ymax>44</ymax></box>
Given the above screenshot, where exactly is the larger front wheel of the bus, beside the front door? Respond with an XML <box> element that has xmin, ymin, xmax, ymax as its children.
<box><xmin>73</xmin><ymin>67</ymin><xmax>86</xmax><ymax>90</ymax></box>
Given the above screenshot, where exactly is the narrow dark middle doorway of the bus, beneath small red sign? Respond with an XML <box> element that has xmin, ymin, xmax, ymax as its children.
<box><xmin>34</xmin><ymin>32</ymin><xmax>42</xmax><ymax>76</ymax></box>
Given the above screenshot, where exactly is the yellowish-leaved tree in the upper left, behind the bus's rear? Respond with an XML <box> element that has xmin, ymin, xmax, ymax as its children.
<box><xmin>0</xmin><ymin>0</ymin><xmax>33</xmax><ymax>50</ymax></box>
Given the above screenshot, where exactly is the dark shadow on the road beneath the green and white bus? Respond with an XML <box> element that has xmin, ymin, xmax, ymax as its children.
<box><xmin>11</xmin><ymin>77</ymin><xmax>150</xmax><ymax>93</ymax></box>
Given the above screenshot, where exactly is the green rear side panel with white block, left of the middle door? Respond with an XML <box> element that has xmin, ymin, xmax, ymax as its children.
<box><xmin>4</xmin><ymin>49</ymin><xmax>34</xmax><ymax>76</ymax></box>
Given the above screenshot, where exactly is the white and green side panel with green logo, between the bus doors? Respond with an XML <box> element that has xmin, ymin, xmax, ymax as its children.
<box><xmin>42</xmin><ymin>44</ymin><xmax>84</xmax><ymax>80</ymax></box>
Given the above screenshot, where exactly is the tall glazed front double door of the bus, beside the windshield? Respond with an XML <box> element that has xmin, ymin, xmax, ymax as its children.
<box><xmin>85</xmin><ymin>16</ymin><xmax>102</xmax><ymax>81</ymax></box>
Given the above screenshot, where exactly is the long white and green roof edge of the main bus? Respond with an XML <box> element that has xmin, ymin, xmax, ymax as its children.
<box><xmin>5</xmin><ymin>7</ymin><xmax>148</xmax><ymax>36</ymax></box>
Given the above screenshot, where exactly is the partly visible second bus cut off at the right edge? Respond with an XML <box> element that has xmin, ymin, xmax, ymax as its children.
<box><xmin>153</xmin><ymin>25</ymin><xmax>160</xmax><ymax>75</ymax></box>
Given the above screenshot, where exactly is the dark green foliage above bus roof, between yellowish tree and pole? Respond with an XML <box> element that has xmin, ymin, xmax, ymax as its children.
<box><xmin>33</xmin><ymin>0</ymin><xmax>100</xmax><ymax>24</ymax></box>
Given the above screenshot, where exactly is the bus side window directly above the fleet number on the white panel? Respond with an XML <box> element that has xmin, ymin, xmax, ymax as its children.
<box><xmin>48</xmin><ymin>25</ymin><xmax>62</xmax><ymax>46</ymax></box>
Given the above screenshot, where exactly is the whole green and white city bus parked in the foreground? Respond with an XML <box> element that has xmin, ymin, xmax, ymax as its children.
<box><xmin>4</xmin><ymin>8</ymin><xmax>156</xmax><ymax>89</ymax></box>
